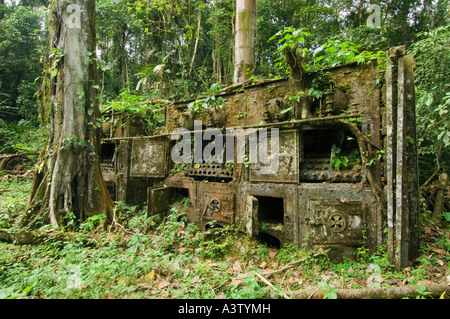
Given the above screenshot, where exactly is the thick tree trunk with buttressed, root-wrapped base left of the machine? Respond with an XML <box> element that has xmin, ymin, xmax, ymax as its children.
<box><xmin>21</xmin><ymin>0</ymin><xmax>113</xmax><ymax>230</ymax></box>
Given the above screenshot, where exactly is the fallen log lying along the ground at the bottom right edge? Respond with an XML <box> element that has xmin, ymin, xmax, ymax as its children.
<box><xmin>291</xmin><ymin>284</ymin><xmax>450</xmax><ymax>299</ymax></box>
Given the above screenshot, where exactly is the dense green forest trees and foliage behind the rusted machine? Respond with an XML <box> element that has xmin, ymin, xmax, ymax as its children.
<box><xmin>0</xmin><ymin>0</ymin><xmax>450</xmax><ymax>178</ymax></box>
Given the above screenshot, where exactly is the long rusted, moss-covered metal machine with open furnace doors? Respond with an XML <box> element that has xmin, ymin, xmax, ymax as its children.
<box><xmin>102</xmin><ymin>47</ymin><xmax>419</xmax><ymax>267</ymax></box>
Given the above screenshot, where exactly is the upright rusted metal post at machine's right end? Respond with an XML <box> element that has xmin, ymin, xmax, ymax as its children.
<box><xmin>386</xmin><ymin>46</ymin><xmax>419</xmax><ymax>269</ymax></box>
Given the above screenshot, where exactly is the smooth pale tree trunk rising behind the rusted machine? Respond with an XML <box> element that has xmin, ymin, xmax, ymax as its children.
<box><xmin>233</xmin><ymin>0</ymin><xmax>256</xmax><ymax>83</ymax></box>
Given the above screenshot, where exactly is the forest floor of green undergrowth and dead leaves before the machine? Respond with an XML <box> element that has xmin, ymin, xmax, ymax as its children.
<box><xmin>0</xmin><ymin>175</ymin><xmax>450</xmax><ymax>299</ymax></box>
